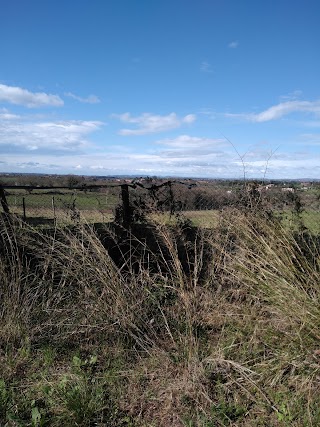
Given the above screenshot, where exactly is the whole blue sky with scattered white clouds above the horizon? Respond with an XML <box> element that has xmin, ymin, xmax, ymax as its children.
<box><xmin>0</xmin><ymin>0</ymin><xmax>320</xmax><ymax>179</ymax></box>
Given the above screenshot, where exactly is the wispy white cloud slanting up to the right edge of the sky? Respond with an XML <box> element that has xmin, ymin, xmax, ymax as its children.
<box><xmin>225</xmin><ymin>100</ymin><xmax>320</xmax><ymax>123</ymax></box>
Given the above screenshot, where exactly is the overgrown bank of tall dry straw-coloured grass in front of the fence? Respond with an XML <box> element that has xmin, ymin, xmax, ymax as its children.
<box><xmin>0</xmin><ymin>210</ymin><xmax>320</xmax><ymax>427</ymax></box>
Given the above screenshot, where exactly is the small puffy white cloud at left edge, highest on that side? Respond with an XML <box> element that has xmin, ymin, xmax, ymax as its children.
<box><xmin>0</xmin><ymin>84</ymin><xmax>63</xmax><ymax>108</ymax></box>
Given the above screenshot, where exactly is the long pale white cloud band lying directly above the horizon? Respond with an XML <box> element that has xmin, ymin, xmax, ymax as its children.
<box><xmin>0</xmin><ymin>135</ymin><xmax>320</xmax><ymax>179</ymax></box>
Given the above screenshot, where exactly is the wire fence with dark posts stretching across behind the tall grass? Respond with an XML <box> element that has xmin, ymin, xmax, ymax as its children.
<box><xmin>0</xmin><ymin>179</ymin><xmax>320</xmax><ymax>234</ymax></box>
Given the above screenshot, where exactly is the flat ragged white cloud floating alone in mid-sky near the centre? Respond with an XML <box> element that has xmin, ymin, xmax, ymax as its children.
<box><xmin>113</xmin><ymin>113</ymin><xmax>196</xmax><ymax>135</ymax></box>
